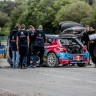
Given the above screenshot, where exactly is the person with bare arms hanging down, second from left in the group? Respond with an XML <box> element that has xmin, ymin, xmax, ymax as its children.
<box><xmin>16</xmin><ymin>24</ymin><xmax>29</xmax><ymax>68</ymax></box>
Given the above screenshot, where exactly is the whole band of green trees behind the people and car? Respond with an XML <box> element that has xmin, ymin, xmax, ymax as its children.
<box><xmin>0</xmin><ymin>0</ymin><xmax>96</xmax><ymax>33</ymax></box>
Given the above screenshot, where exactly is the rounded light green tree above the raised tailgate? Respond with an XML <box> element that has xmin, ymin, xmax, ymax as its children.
<box><xmin>55</xmin><ymin>1</ymin><xmax>92</xmax><ymax>26</ymax></box>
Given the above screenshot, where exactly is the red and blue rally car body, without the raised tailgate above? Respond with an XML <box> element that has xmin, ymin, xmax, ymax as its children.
<box><xmin>40</xmin><ymin>34</ymin><xmax>89</xmax><ymax>67</ymax></box>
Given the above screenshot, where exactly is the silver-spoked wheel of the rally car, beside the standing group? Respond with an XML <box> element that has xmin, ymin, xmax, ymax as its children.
<box><xmin>47</xmin><ymin>52</ymin><xmax>59</xmax><ymax>67</ymax></box>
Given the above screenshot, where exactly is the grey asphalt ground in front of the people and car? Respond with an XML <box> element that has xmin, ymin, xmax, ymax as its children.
<box><xmin>0</xmin><ymin>59</ymin><xmax>96</xmax><ymax>96</ymax></box>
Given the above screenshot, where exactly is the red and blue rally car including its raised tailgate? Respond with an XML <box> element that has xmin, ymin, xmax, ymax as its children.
<box><xmin>39</xmin><ymin>21</ymin><xmax>89</xmax><ymax>67</ymax></box>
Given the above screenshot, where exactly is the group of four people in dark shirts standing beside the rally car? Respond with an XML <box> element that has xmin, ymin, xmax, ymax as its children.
<box><xmin>10</xmin><ymin>24</ymin><xmax>45</xmax><ymax>68</ymax></box>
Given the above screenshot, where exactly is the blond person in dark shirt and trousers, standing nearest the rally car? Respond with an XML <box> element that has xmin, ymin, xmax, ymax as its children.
<box><xmin>33</xmin><ymin>25</ymin><xmax>45</xmax><ymax>67</ymax></box>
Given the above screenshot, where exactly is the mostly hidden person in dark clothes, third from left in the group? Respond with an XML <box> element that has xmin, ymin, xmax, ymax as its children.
<box><xmin>27</xmin><ymin>25</ymin><xmax>35</xmax><ymax>66</ymax></box>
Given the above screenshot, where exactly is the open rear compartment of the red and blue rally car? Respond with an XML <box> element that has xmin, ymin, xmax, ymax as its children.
<box><xmin>60</xmin><ymin>38</ymin><xmax>83</xmax><ymax>54</ymax></box>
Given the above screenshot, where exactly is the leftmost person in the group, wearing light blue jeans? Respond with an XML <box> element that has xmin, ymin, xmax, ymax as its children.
<box><xmin>10</xmin><ymin>25</ymin><xmax>20</xmax><ymax>68</ymax></box>
